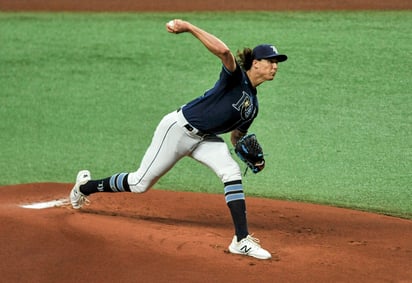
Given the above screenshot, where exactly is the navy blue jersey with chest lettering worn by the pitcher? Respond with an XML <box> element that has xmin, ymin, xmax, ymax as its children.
<box><xmin>182</xmin><ymin>64</ymin><xmax>258</xmax><ymax>134</ymax></box>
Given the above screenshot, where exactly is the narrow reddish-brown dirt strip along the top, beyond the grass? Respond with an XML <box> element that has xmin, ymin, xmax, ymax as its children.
<box><xmin>0</xmin><ymin>0</ymin><xmax>412</xmax><ymax>12</ymax></box>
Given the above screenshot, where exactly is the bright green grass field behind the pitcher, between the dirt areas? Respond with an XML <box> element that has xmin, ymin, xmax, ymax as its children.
<box><xmin>0</xmin><ymin>11</ymin><xmax>412</xmax><ymax>218</ymax></box>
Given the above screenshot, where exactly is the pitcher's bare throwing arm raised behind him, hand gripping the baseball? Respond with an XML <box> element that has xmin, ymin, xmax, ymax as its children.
<box><xmin>166</xmin><ymin>19</ymin><xmax>236</xmax><ymax>72</ymax></box>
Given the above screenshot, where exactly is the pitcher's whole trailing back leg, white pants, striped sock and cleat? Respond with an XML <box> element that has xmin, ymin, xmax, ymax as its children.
<box><xmin>70</xmin><ymin>112</ymin><xmax>199</xmax><ymax>208</ymax></box>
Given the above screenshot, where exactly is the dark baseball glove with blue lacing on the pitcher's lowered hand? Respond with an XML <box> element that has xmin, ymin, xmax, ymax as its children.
<box><xmin>235</xmin><ymin>134</ymin><xmax>265</xmax><ymax>174</ymax></box>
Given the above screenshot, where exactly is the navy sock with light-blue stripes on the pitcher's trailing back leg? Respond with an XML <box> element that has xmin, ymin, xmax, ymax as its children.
<box><xmin>80</xmin><ymin>173</ymin><xmax>130</xmax><ymax>196</ymax></box>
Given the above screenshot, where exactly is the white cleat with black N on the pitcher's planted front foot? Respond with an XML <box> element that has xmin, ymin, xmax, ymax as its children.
<box><xmin>229</xmin><ymin>235</ymin><xmax>272</xmax><ymax>259</ymax></box>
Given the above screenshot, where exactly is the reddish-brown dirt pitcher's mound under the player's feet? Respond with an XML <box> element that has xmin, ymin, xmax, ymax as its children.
<box><xmin>0</xmin><ymin>183</ymin><xmax>412</xmax><ymax>283</ymax></box>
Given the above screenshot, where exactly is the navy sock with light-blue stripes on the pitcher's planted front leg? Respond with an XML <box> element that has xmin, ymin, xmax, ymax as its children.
<box><xmin>225</xmin><ymin>180</ymin><xmax>249</xmax><ymax>241</ymax></box>
